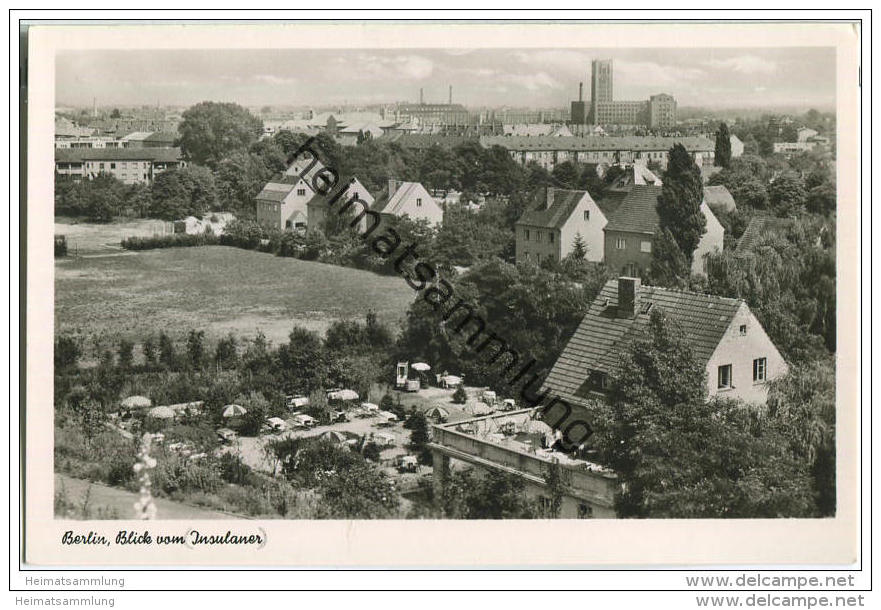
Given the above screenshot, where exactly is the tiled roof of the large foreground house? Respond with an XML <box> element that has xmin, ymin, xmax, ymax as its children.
<box><xmin>543</xmin><ymin>279</ymin><xmax>743</xmax><ymax>404</ymax></box>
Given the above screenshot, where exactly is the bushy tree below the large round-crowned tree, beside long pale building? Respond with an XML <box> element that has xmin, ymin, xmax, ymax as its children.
<box><xmin>151</xmin><ymin>165</ymin><xmax>217</xmax><ymax>220</ymax></box>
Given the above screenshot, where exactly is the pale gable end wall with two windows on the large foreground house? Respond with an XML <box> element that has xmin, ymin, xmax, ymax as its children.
<box><xmin>706</xmin><ymin>303</ymin><xmax>788</xmax><ymax>404</ymax></box>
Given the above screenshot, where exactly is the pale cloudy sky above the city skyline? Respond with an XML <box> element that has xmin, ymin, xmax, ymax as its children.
<box><xmin>55</xmin><ymin>47</ymin><xmax>835</xmax><ymax>109</ymax></box>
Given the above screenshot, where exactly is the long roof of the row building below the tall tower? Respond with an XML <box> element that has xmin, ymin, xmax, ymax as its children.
<box><xmin>480</xmin><ymin>136</ymin><xmax>716</xmax><ymax>152</ymax></box>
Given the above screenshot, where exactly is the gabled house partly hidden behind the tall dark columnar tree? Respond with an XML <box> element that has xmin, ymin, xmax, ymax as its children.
<box><xmin>604</xmin><ymin>185</ymin><xmax>725</xmax><ymax>276</ymax></box>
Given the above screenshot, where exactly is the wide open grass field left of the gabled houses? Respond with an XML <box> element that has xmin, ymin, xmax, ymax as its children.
<box><xmin>55</xmin><ymin>246</ymin><xmax>415</xmax><ymax>358</ymax></box>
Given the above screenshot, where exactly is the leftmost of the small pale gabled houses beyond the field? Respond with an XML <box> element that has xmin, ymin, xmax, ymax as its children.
<box><xmin>255</xmin><ymin>153</ymin><xmax>324</xmax><ymax>231</ymax></box>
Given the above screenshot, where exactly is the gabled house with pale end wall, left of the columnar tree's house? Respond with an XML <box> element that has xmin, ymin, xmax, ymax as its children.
<box><xmin>514</xmin><ymin>187</ymin><xmax>613</xmax><ymax>263</ymax></box>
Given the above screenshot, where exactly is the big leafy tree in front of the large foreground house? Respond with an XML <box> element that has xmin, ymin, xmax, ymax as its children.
<box><xmin>594</xmin><ymin>308</ymin><xmax>813</xmax><ymax>518</ymax></box>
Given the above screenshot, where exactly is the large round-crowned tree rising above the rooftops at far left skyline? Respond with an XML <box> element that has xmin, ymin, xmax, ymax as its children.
<box><xmin>178</xmin><ymin>102</ymin><xmax>263</xmax><ymax>168</ymax></box>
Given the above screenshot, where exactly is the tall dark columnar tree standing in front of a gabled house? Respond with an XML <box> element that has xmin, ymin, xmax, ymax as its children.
<box><xmin>658</xmin><ymin>144</ymin><xmax>707</xmax><ymax>267</ymax></box>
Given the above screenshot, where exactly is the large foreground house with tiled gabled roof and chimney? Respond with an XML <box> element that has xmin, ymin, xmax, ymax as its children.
<box><xmin>543</xmin><ymin>277</ymin><xmax>788</xmax><ymax>408</ymax></box>
